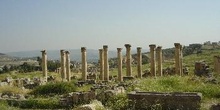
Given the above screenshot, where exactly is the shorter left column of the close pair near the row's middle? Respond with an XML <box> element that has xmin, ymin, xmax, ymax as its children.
<box><xmin>99</xmin><ymin>49</ymin><xmax>104</xmax><ymax>81</ymax></box>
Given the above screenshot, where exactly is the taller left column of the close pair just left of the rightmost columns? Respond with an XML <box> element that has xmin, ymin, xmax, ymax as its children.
<box><xmin>149</xmin><ymin>44</ymin><xmax>156</xmax><ymax>76</ymax></box>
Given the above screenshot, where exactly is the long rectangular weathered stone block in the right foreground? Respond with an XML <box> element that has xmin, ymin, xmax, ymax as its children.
<box><xmin>128</xmin><ymin>92</ymin><xmax>202</xmax><ymax>110</ymax></box>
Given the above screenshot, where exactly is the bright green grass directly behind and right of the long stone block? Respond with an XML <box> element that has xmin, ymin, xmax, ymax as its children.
<box><xmin>134</xmin><ymin>76</ymin><xmax>220</xmax><ymax>98</ymax></box>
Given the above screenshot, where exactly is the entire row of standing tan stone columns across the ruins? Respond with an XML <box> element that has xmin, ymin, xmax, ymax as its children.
<box><xmin>41</xmin><ymin>43</ymin><xmax>183</xmax><ymax>81</ymax></box>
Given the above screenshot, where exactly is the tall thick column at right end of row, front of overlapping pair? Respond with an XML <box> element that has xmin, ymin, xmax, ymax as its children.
<box><xmin>174</xmin><ymin>43</ymin><xmax>181</xmax><ymax>75</ymax></box>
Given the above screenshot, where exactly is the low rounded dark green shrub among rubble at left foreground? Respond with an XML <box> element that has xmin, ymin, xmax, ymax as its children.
<box><xmin>31</xmin><ymin>82</ymin><xmax>76</xmax><ymax>95</ymax></box>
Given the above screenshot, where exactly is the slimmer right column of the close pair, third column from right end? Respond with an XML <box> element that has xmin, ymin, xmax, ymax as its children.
<box><xmin>157</xmin><ymin>46</ymin><xmax>163</xmax><ymax>76</ymax></box>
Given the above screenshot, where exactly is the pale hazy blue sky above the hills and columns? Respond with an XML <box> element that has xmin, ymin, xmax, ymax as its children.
<box><xmin>0</xmin><ymin>0</ymin><xmax>220</xmax><ymax>52</ymax></box>
